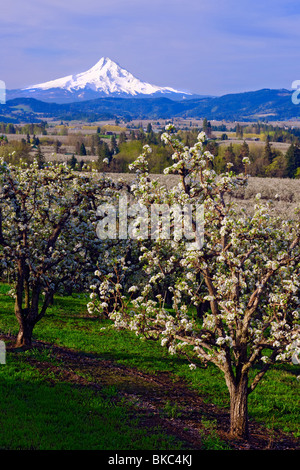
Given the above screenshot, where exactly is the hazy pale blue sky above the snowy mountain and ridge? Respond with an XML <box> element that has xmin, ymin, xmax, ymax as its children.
<box><xmin>0</xmin><ymin>0</ymin><xmax>300</xmax><ymax>95</ymax></box>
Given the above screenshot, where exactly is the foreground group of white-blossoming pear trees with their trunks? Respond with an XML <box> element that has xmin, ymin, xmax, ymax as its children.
<box><xmin>0</xmin><ymin>125</ymin><xmax>300</xmax><ymax>439</ymax></box>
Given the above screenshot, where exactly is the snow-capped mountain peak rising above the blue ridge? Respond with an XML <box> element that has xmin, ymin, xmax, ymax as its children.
<box><xmin>9</xmin><ymin>57</ymin><xmax>192</xmax><ymax>103</ymax></box>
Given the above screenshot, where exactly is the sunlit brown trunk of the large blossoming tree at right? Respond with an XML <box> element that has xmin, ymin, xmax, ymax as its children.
<box><xmin>229</xmin><ymin>375</ymin><xmax>249</xmax><ymax>439</ymax></box>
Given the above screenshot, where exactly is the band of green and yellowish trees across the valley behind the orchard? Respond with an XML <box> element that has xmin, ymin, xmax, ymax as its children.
<box><xmin>0</xmin><ymin>119</ymin><xmax>300</xmax><ymax>178</ymax></box>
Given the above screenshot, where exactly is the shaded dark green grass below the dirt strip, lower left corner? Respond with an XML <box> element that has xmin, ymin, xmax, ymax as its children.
<box><xmin>0</xmin><ymin>354</ymin><xmax>181</xmax><ymax>450</ymax></box>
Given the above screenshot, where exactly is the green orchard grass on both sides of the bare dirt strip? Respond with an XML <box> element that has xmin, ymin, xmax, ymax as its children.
<box><xmin>0</xmin><ymin>285</ymin><xmax>300</xmax><ymax>450</ymax></box>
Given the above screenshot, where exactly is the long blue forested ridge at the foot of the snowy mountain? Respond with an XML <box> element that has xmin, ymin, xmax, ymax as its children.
<box><xmin>0</xmin><ymin>89</ymin><xmax>300</xmax><ymax>122</ymax></box>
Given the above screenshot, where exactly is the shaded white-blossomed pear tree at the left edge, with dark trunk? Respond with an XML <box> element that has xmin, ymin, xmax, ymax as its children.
<box><xmin>0</xmin><ymin>161</ymin><xmax>116</xmax><ymax>347</ymax></box>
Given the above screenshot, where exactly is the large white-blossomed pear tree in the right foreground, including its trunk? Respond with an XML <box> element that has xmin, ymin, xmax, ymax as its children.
<box><xmin>90</xmin><ymin>125</ymin><xmax>300</xmax><ymax>439</ymax></box>
